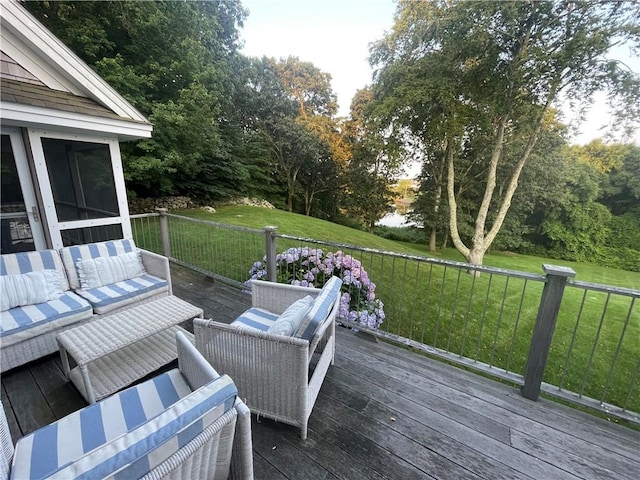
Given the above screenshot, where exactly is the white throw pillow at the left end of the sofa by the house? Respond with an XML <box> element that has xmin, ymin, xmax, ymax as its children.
<box><xmin>0</xmin><ymin>269</ymin><xmax>62</xmax><ymax>312</ymax></box>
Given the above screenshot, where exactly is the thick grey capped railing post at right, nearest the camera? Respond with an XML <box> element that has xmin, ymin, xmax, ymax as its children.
<box><xmin>520</xmin><ymin>264</ymin><xmax>576</xmax><ymax>401</ymax></box>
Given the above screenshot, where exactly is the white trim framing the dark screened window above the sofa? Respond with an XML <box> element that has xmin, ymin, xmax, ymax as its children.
<box><xmin>28</xmin><ymin>129</ymin><xmax>132</xmax><ymax>249</ymax></box>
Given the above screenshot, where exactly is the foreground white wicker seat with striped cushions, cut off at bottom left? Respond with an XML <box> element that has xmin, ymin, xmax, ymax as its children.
<box><xmin>0</xmin><ymin>333</ymin><xmax>253</xmax><ymax>480</ymax></box>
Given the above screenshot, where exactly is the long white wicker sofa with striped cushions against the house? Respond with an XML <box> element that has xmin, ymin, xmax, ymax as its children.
<box><xmin>0</xmin><ymin>239</ymin><xmax>171</xmax><ymax>372</ymax></box>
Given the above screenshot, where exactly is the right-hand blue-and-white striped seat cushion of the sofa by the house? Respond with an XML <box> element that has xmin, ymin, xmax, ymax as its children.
<box><xmin>76</xmin><ymin>274</ymin><xmax>169</xmax><ymax>315</ymax></box>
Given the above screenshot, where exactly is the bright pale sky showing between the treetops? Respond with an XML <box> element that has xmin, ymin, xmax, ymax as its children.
<box><xmin>241</xmin><ymin>0</ymin><xmax>640</xmax><ymax>145</ymax></box>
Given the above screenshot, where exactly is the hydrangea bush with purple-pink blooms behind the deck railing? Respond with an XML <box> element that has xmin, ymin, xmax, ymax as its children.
<box><xmin>249</xmin><ymin>247</ymin><xmax>385</xmax><ymax>328</ymax></box>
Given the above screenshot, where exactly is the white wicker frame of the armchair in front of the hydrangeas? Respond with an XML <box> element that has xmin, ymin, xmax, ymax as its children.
<box><xmin>194</xmin><ymin>280</ymin><xmax>341</xmax><ymax>439</ymax></box>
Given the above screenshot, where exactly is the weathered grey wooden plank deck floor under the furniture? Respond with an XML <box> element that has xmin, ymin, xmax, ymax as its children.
<box><xmin>2</xmin><ymin>266</ymin><xmax>640</xmax><ymax>480</ymax></box>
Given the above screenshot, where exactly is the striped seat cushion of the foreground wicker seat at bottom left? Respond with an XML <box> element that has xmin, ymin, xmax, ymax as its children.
<box><xmin>11</xmin><ymin>369</ymin><xmax>191</xmax><ymax>479</ymax></box>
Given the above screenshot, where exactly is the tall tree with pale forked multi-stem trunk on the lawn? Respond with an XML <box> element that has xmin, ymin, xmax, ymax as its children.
<box><xmin>371</xmin><ymin>0</ymin><xmax>640</xmax><ymax>264</ymax></box>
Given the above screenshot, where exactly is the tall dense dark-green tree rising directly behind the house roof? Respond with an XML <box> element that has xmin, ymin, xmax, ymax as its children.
<box><xmin>25</xmin><ymin>0</ymin><xmax>252</xmax><ymax>199</ymax></box>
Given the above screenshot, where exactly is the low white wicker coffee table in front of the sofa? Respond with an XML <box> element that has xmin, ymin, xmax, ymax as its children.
<box><xmin>57</xmin><ymin>295</ymin><xmax>203</xmax><ymax>403</ymax></box>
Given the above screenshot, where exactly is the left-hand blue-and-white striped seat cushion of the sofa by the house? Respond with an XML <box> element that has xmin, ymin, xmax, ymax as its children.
<box><xmin>0</xmin><ymin>292</ymin><xmax>93</xmax><ymax>347</ymax></box>
